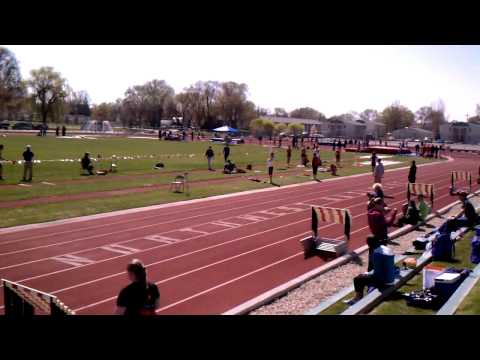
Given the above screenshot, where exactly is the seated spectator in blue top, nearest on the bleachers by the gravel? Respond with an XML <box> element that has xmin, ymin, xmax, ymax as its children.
<box><xmin>347</xmin><ymin>243</ymin><xmax>395</xmax><ymax>305</ymax></box>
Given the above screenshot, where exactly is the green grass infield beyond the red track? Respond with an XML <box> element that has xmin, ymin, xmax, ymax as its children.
<box><xmin>0</xmin><ymin>135</ymin><xmax>438</xmax><ymax>227</ymax></box>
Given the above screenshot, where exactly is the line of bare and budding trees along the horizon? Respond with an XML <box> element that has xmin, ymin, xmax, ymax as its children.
<box><xmin>0</xmin><ymin>47</ymin><xmax>472</xmax><ymax>137</ymax></box>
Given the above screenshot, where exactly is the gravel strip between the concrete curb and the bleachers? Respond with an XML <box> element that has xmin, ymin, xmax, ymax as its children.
<box><xmin>249</xmin><ymin>196</ymin><xmax>480</xmax><ymax>315</ymax></box>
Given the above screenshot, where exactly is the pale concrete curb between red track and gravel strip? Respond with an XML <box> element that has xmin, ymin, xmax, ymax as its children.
<box><xmin>222</xmin><ymin>188</ymin><xmax>480</xmax><ymax>315</ymax></box>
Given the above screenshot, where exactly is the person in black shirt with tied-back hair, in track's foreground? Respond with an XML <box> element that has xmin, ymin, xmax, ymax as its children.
<box><xmin>115</xmin><ymin>259</ymin><xmax>160</xmax><ymax>316</ymax></box>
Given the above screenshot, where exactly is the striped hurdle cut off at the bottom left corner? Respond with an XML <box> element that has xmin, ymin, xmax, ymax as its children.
<box><xmin>2</xmin><ymin>279</ymin><xmax>75</xmax><ymax>317</ymax></box>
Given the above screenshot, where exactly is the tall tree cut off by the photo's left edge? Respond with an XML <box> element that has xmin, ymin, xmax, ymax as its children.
<box><xmin>0</xmin><ymin>47</ymin><xmax>25</xmax><ymax>118</ymax></box>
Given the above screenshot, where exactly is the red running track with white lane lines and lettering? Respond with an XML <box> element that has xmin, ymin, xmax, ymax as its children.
<box><xmin>0</xmin><ymin>155</ymin><xmax>478</xmax><ymax>314</ymax></box>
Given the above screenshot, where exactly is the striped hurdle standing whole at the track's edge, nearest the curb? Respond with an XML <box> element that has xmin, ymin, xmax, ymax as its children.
<box><xmin>300</xmin><ymin>206</ymin><xmax>352</xmax><ymax>258</ymax></box>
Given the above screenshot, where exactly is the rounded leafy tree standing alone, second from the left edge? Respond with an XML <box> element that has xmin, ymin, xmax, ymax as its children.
<box><xmin>28</xmin><ymin>67</ymin><xmax>68</xmax><ymax>123</ymax></box>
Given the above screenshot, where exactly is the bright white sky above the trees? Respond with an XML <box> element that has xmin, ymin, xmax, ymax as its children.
<box><xmin>0</xmin><ymin>45</ymin><xmax>480</xmax><ymax>121</ymax></box>
